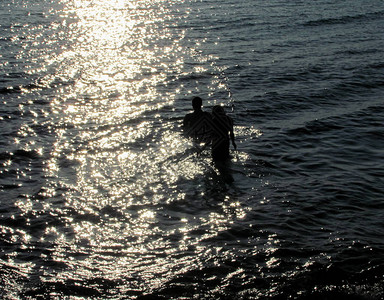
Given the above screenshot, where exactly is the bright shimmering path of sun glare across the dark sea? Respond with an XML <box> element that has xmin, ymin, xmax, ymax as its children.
<box><xmin>31</xmin><ymin>1</ymin><xmax>254</xmax><ymax>291</ymax></box>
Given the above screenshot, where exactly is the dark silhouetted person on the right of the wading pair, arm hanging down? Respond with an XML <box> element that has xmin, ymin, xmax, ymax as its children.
<box><xmin>211</xmin><ymin>105</ymin><xmax>237</xmax><ymax>161</ymax></box>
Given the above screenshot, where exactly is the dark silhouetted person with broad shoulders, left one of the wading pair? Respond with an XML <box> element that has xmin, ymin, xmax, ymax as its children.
<box><xmin>183</xmin><ymin>97</ymin><xmax>212</xmax><ymax>143</ymax></box>
